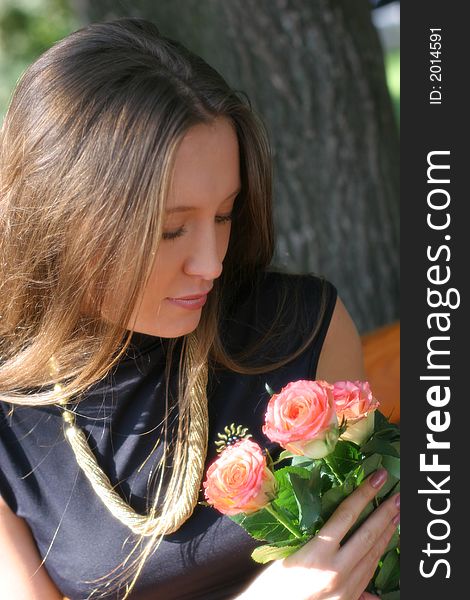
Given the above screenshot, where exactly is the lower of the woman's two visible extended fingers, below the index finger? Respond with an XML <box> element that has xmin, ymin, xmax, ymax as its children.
<box><xmin>337</xmin><ymin>494</ymin><xmax>400</xmax><ymax>569</ymax></box>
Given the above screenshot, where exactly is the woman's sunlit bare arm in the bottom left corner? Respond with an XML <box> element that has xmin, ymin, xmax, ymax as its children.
<box><xmin>0</xmin><ymin>497</ymin><xmax>63</xmax><ymax>600</ymax></box>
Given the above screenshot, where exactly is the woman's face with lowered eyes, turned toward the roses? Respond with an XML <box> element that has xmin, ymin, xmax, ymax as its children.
<box><xmin>107</xmin><ymin>118</ymin><xmax>240</xmax><ymax>337</ymax></box>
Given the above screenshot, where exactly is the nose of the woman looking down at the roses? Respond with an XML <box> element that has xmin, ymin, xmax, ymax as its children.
<box><xmin>185</xmin><ymin>230</ymin><xmax>226</xmax><ymax>281</ymax></box>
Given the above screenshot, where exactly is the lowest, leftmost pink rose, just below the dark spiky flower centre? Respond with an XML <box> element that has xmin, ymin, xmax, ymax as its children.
<box><xmin>202</xmin><ymin>439</ymin><xmax>277</xmax><ymax>515</ymax></box>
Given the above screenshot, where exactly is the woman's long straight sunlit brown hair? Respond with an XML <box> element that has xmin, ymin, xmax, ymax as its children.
<box><xmin>0</xmin><ymin>19</ymin><xmax>328</xmax><ymax>598</ymax></box>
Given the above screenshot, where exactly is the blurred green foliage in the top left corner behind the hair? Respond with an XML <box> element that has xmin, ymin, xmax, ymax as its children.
<box><xmin>0</xmin><ymin>0</ymin><xmax>80</xmax><ymax>118</ymax></box>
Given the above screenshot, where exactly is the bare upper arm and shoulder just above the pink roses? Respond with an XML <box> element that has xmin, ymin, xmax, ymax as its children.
<box><xmin>316</xmin><ymin>296</ymin><xmax>365</xmax><ymax>382</ymax></box>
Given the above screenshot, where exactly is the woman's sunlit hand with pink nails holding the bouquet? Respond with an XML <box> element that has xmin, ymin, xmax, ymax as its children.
<box><xmin>238</xmin><ymin>469</ymin><xmax>400</xmax><ymax>600</ymax></box>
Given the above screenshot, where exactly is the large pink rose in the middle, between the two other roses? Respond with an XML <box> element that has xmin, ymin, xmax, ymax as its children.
<box><xmin>263</xmin><ymin>379</ymin><xmax>338</xmax><ymax>458</ymax></box>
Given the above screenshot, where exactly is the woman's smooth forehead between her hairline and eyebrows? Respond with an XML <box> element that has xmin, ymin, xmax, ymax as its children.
<box><xmin>167</xmin><ymin>118</ymin><xmax>240</xmax><ymax>212</ymax></box>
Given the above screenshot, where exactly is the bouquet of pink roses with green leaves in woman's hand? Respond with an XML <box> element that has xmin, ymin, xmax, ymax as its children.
<box><xmin>203</xmin><ymin>380</ymin><xmax>400</xmax><ymax>600</ymax></box>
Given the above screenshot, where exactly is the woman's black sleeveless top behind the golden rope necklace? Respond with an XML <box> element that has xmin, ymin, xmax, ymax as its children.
<box><xmin>0</xmin><ymin>272</ymin><xmax>336</xmax><ymax>600</ymax></box>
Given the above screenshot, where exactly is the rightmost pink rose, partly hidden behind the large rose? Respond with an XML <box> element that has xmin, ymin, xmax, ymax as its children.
<box><xmin>333</xmin><ymin>381</ymin><xmax>379</xmax><ymax>445</ymax></box>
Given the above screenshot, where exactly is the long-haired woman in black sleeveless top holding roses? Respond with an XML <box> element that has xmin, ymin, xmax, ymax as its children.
<box><xmin>0</xmin><ymin>19</ymin><xmax>399</xmax><ymax>600</ymax></box>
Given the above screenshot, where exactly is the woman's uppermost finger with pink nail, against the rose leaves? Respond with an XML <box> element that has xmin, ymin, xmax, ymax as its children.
<box><xmin>315</xmin><ymin>469</ymin><xmax>388</xmax><ymax>555</ymax></box>
